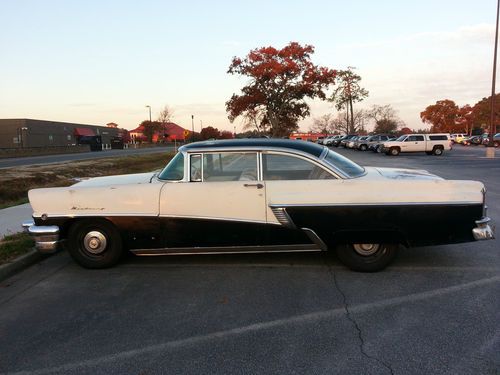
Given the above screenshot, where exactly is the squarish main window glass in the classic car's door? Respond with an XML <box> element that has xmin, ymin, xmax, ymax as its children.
<box><xmin>203</xmin><ymin>152</ymin><xmax>257</xmax><ymax>181</ymax></box>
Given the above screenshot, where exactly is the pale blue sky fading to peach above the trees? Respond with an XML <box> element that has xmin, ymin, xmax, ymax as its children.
<box><xmin>0</xmin><ymin>0</ymin><xmax>498</xmax><ymax>132</ymax></box>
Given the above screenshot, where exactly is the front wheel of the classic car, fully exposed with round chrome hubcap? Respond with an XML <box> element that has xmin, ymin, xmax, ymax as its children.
<box><xmin>68</xmin><ymin>219</ymin><xmax>123</xmax><ymax>268</ymax></box>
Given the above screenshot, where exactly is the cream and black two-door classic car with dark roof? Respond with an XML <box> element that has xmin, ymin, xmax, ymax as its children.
<box><xmin>24</xmin><ymin>139</ymin><xmax>493</xmax><ymax>272</ymax></box>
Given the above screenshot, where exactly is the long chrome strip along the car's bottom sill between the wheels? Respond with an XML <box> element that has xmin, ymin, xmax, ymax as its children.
<box><xmin>130</xmin><ymin>244</ymin><xmax>321</xmax><ymax>256</ymax></box>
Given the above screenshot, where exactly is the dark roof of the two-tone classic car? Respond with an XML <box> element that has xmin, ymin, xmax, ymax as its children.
<box><xmin>180</xmin><ymin>138</ymin><xmax>325</xmax><ymax>157</ymax></box>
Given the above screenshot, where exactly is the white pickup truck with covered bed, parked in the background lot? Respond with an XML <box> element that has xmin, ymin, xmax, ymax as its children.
<box><xmin>383</xmin><ymin>133</ymin><xmax>451</xmax><ymax>156</ymax></box>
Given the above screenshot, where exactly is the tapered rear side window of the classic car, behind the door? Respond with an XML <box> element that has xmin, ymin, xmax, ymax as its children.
<box><xmin>262</xmin><ymin>154</ymin><xmax>335</xmax><ymax>181</ymax></box>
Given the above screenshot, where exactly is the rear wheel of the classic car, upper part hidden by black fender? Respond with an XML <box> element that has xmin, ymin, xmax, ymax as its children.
<box><xmin>336</xmin><ymin>244</ymin><xmax>398</xmax><ymax>272</ymax></box>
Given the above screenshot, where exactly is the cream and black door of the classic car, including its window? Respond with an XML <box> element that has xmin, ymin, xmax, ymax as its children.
<box><xmin>160</xmin><ymin>152</ymin><xmax>266</xmax><ymax>247</ymax></box>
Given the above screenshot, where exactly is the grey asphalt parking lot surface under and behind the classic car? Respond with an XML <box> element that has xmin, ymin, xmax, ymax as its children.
<box><xmin>0</xmin><ymin>146</ymin><xmax>500</xmax><ymax>375</ymax></box>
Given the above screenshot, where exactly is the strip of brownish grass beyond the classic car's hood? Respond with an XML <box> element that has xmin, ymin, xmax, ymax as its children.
<box><xmin>0</xmin><ymin>153</ymin><xmax>174</xmax><ymax>208</ymax></box>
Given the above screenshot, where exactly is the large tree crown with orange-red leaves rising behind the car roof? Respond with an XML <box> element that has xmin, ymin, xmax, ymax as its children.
<box><xmin>226</xmin><ymin>42</ymin><xmax>336</xmax><ymax>137</ymax></box>
